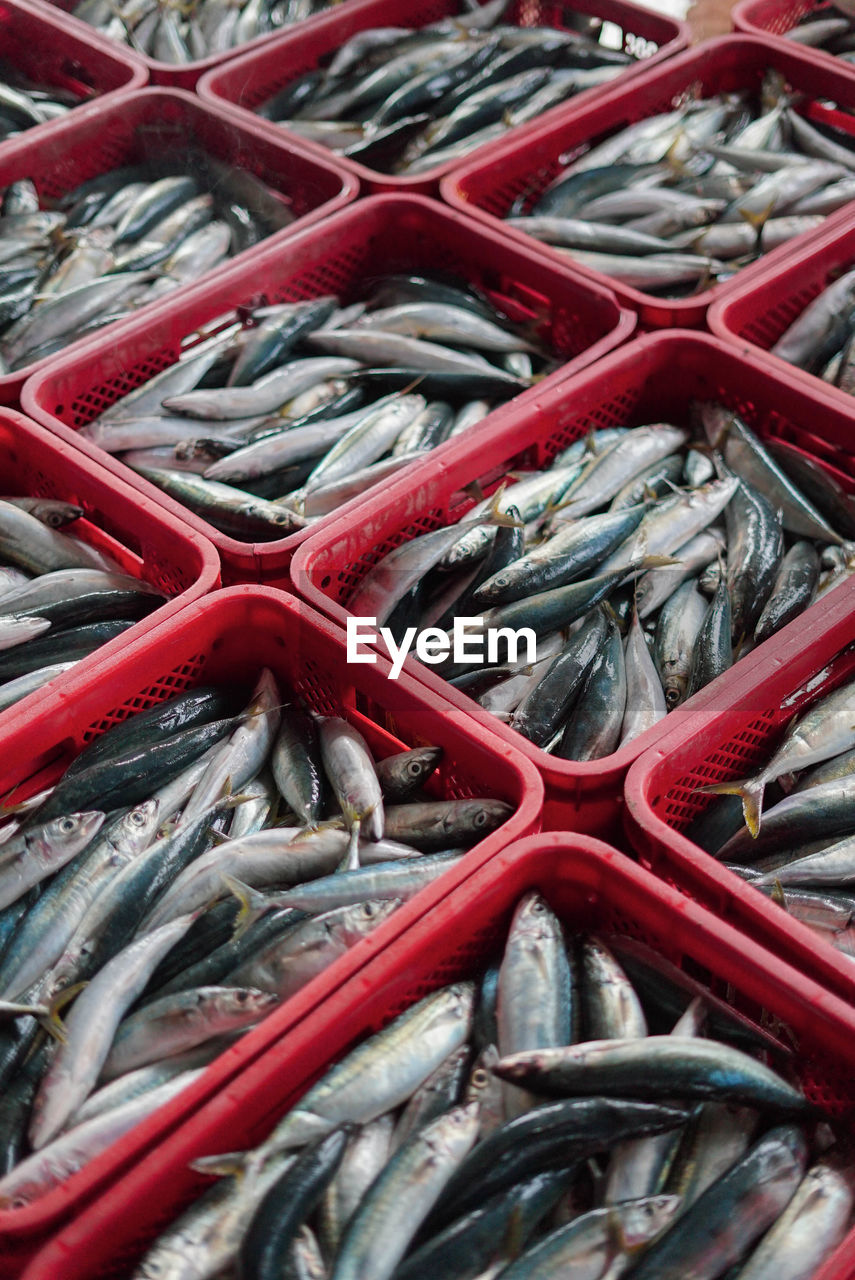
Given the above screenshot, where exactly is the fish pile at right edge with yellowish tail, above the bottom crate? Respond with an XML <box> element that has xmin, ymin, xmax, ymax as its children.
<box><xmin>686</xmin><ymin>682</ymin><xmax>855</xmax><ymax>959</ymax></box>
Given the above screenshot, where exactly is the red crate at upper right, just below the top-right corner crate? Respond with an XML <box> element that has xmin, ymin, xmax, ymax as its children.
<box><xmin>440</xmin><ymin>36</ymin><xmax>855</xmax><ymax>329</ymax></box>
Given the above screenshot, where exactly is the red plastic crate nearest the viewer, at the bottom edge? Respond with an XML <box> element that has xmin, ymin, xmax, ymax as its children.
<box><xmin>24</xmin><ymin>833</ymin><xmax>855</xmax><ymax>1280</ymax></box>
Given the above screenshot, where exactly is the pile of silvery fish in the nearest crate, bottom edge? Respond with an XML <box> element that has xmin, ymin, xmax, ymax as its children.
<box><xmin>132</xmin><ymin>892</ymin><xmax>855</xmax><ymax>1280</ymax></box>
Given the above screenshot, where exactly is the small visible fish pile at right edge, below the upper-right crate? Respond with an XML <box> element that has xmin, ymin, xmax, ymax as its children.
<box><xmin>772</xmin><ymin>262</ymin><xmax>855</xmax><ymax>396</ymax></box>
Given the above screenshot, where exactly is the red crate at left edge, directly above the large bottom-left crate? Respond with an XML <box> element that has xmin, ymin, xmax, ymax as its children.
<box><xmin>0</xmin><ymin>408</ymin><xmax>220</xmax><ymax>727</ymax></box>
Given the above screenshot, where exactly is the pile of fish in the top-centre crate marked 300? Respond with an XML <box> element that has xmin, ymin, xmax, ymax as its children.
<box><xmin>256</xmin><ymin>0</ymin><xmax>634</xmax><ymax>174</ymax></box>
